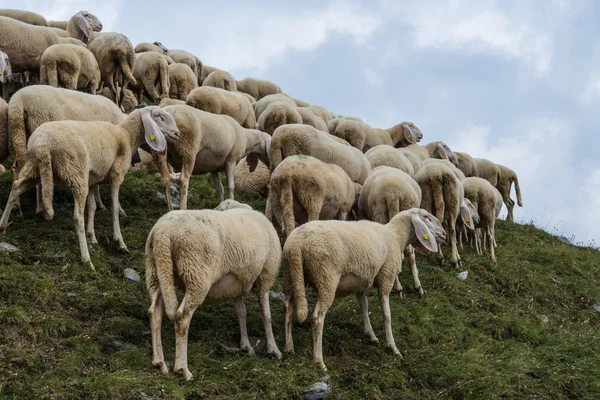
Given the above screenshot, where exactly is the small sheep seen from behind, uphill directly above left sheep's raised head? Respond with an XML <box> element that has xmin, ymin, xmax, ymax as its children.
<box><xmin>131</xmin><ymin>51</ymin><xmax>169</xmax><ymax>103</ymax></box>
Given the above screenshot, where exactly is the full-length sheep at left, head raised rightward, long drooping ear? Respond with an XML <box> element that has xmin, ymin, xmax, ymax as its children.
<box><xmin>0</xmin><ymin>106</ymin><xmax>178</xmax><ymax>270</ymax></box>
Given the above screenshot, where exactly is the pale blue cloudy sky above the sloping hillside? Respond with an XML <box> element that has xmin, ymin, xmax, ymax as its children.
<box><xmin>16</xmin><ymin>0</ymin><xmax>600</xmax><ymax>246</ymax></box>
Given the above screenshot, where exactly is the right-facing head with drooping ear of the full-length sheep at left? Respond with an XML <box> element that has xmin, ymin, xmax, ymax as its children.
<box><xmin>142</xmin><ymin>106</ymin><xmax>179</xmax><ymax>154</ymax></box>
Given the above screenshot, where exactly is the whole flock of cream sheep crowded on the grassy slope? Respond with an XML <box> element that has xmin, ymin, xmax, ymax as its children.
<box><xmin>0</xmin><ymin>9</ymin><xmax>522</xmax><ymax>379</ymax></box>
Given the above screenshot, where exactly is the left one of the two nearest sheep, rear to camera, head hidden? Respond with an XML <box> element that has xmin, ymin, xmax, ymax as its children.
<box><xmin>145</xmin><ymin>200</ymin><xmax>281</xmax><ymax>381</ymax></box>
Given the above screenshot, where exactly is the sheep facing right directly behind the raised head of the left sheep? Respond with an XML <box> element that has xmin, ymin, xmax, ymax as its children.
<box><xmin>161</xmin><ymin>105</ymin><xmax>271</xmax><ymax>210</ymax></box>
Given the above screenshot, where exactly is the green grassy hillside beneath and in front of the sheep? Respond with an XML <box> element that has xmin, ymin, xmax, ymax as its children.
<box><xmin>0</xmin><ymin>167</ymin><xmax>600</xmax><ymax>399</ymax></box>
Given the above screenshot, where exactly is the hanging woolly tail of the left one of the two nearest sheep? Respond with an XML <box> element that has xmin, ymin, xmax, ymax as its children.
<box><xmin>148</xmin><ymin>229</ymin><xmax>179</xmax><ymax>321</ymax></box>
